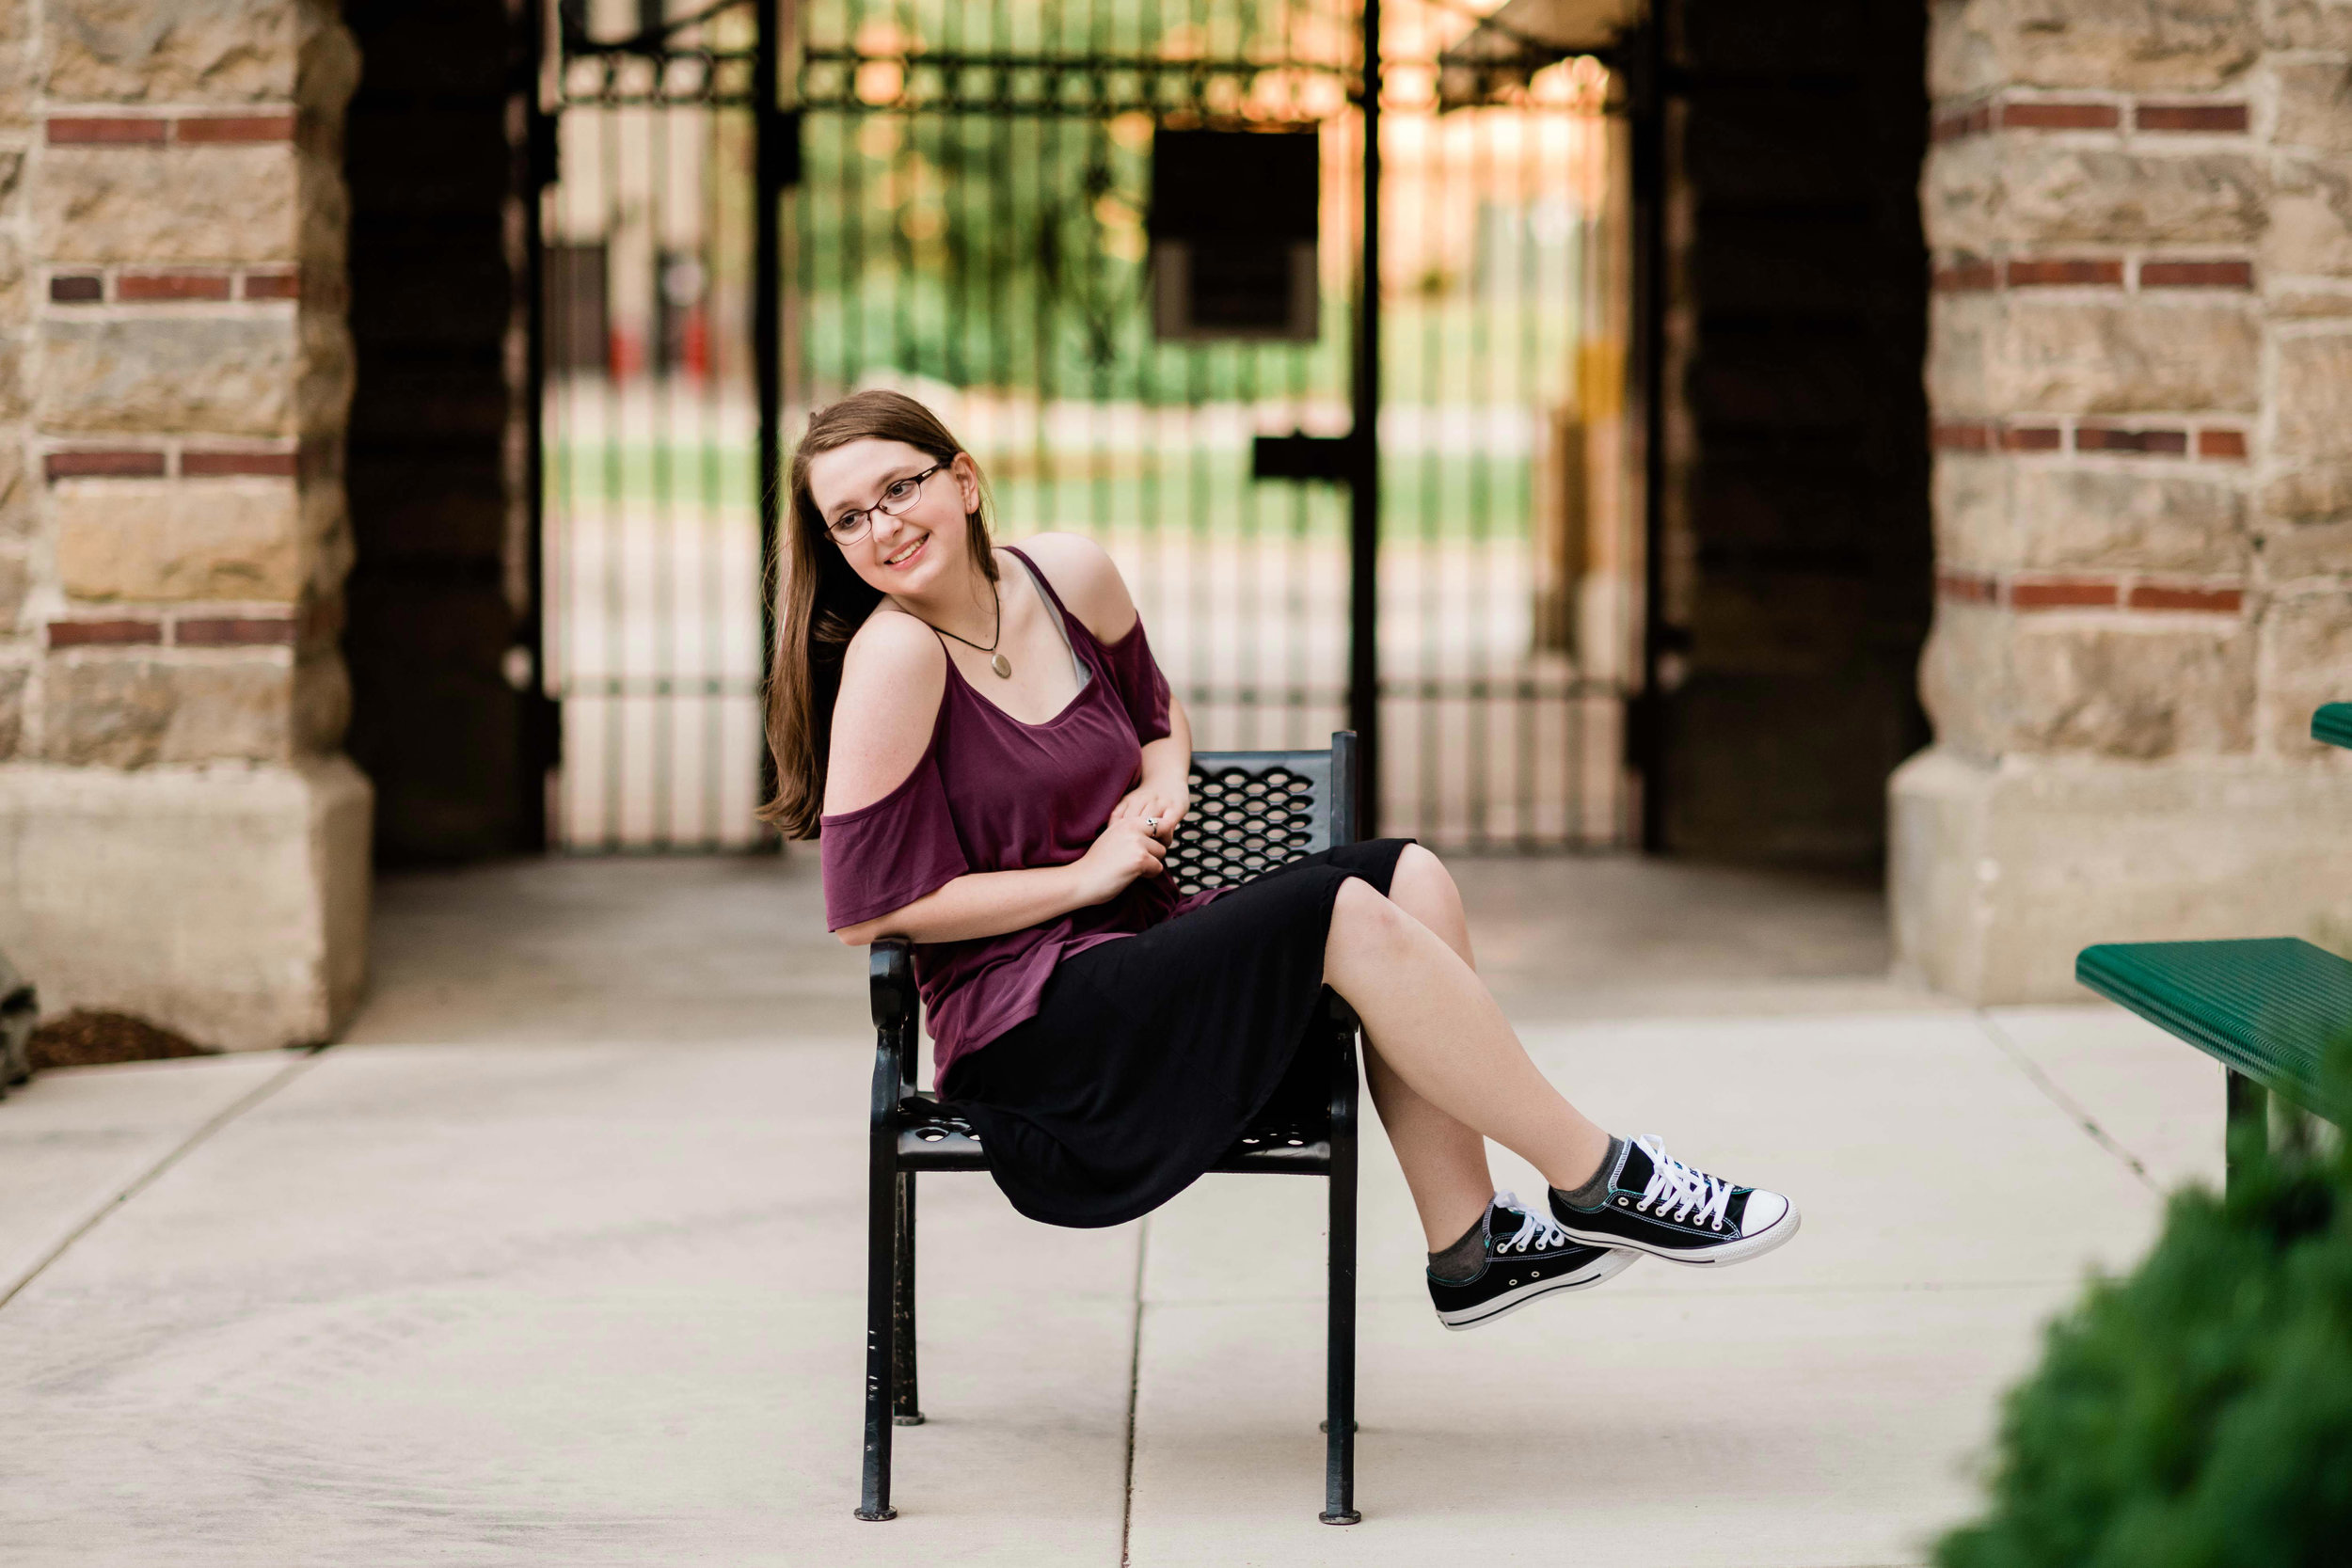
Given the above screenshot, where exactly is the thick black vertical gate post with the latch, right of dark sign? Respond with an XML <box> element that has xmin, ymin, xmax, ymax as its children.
<box><xmin>1348</xmin><ymin>0</ymin><xmax>1381</xmax><ymax>837</ymax></box>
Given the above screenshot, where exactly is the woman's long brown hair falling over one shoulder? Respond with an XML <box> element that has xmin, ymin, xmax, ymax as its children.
<box><xmin>760</xmin><ymin>390</ymin><xmax>997</xmax><ymax>839</ymax></box>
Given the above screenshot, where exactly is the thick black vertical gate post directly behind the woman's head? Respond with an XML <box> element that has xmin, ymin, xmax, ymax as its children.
<box><xmin>751</xmin><ymin>0</ymin><xmax>786</xmax><ymax>827</ymax></box>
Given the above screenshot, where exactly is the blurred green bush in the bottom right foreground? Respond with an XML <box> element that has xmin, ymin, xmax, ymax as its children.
<box><xmin>1936</xmin><ymin>1041</ymin><xmax>2352</xmax><ymax>1568</ymax></box>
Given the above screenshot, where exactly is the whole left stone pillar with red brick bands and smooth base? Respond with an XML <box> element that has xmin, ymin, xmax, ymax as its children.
<box><xmin>0</xmin><ymin>0</ymin><xmax>370</xmax><ymax>1046</ymax></box>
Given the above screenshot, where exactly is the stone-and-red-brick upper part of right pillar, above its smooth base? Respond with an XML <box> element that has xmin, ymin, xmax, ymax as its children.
<box><xmin>1922</xmin><ymin>0</ymin><xmax>2352</xmax><ymax>764</ymax></box>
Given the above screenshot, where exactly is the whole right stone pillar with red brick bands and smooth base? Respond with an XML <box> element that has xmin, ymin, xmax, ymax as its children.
<box><xmin>1889</xmin><ymin>0</ymin><xmax>2352</xmax><ymax>1002</ymax></box>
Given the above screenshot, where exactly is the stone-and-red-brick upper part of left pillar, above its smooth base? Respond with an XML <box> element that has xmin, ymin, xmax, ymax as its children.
<box><xmin>0</xmin><ymin>0</ymin><xmax>358</xmax><ymax>768</ymax></box>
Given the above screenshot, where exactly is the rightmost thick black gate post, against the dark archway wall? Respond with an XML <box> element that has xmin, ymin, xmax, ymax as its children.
<box><xmin>1630</xmin><ymin>5</ymin><xmax>1668</xmax><ymax>853</ymax></box>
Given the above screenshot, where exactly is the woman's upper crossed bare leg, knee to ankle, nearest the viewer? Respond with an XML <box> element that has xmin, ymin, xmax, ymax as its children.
<box><xmin>1325</xmin><ymin>851</ymin><xmax>1609</xmax><ymax>1212</ymax></box>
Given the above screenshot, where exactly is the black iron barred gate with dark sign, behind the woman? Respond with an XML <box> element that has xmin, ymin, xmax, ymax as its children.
<box><xmin>541</xmin><ymin>0</ymin><xmax>1632</xmax><ymax>848</ymax></box>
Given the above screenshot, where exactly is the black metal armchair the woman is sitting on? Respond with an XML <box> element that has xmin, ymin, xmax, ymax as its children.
<box><xmin>859</xmin><ymin>731</ymin><xmax>1362</xmax><ymax>1524</ymax></box>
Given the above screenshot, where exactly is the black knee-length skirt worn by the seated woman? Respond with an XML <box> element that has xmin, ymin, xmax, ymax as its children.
<box><xmin>941</xmin><ymin>839</ymin><xmax>1411</xmax><ymax>1227</ymax></box>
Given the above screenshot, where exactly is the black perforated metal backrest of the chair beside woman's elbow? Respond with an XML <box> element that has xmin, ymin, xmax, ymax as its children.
<box><xmin>1167</xmin><ymin>729</ymin><xmax>1358</xmax><ymax>894</ymax></box>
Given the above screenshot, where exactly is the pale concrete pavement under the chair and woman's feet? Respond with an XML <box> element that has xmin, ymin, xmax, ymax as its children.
<box><xmin>0</xmin><ymin>861</ymin><xmax>2220</xmax><ymax>1568</ymax></box>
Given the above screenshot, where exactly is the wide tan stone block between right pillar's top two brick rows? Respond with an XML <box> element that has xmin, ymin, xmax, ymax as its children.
<box><xmin>1919</xmin><ymin>134</ymin><xmax>2267</xmax><ymax>254</ymax></box>
